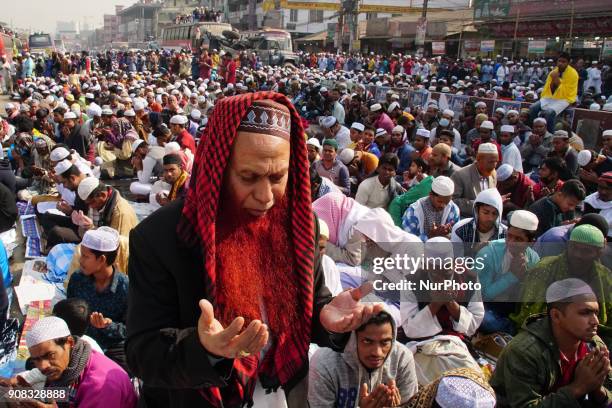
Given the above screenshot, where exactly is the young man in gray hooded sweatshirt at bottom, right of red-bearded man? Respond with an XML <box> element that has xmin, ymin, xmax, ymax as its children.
<box><xmin>308</xmin><ymin>311</ymin><xmax>418</xmax><ymax>408</ymax></box>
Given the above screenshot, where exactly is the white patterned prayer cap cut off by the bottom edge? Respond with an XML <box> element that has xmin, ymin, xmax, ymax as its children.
<box><xmin>436</xmin><ymin>375</ymin><xmax>495</xmax><ymax>408</ymax></box>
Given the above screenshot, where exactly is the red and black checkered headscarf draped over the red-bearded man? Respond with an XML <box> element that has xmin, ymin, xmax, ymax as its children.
<box><xmin>177</xmin><ymin>92</ymin><xmax>314</xmax><ymax>407</ymax></box>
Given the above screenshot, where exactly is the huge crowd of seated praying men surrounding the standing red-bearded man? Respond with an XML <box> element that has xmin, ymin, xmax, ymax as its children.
<box><xmin>0</xmin><ymin>47</ymin><xmax>612</xmax><ymax>407</ymax></box>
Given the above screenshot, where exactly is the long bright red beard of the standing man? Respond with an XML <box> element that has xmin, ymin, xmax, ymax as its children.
<box><xmin>215</xmin><ymin>199</ymin><xmax>298</xmax><ymax>333</ymax></box>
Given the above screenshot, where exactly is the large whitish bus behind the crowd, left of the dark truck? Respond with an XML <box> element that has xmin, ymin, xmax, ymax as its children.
<box><xmin>159</xmin><ymin>22</ymin><xmax>234</xmax><ymax>50</ymax></box>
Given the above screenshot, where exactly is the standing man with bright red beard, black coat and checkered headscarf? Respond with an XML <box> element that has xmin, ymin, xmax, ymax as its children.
<box><xmin>126</xmin><ymin>92</ymin><xmax>382</xmax><ymax>407</ymax></box>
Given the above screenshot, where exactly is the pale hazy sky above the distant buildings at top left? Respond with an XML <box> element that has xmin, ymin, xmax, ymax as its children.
<box><xmin>0</xmin><ymin>0</ymin><xmax>128</xmax><ymax>32</ymax></box>
